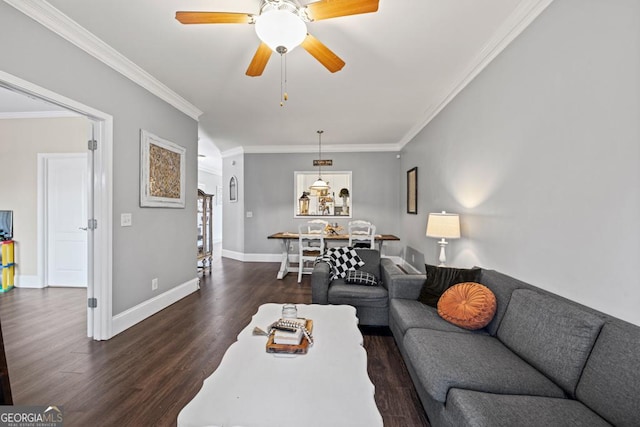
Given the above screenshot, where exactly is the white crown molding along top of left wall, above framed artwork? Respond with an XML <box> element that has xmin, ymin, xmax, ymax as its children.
<box><xmin>4</xmin><ymin>0</ymin><xmax>202</xmax><ymax>121</ymax></box>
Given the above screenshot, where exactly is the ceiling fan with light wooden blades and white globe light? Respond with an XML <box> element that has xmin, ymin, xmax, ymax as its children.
<box><xmin>176</xmin><ymin>0</ymin><xmax>379</xmax><ymax>77</ymax></box>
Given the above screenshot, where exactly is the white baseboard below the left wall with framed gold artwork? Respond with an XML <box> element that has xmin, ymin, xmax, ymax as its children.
<box><xmin>111</xmin><ymin>277</ymin><xmax>200</xmax><ymax>337</ymax></box>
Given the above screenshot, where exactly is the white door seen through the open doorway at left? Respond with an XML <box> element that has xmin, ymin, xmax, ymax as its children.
<box><xmin>46</xmin><ymin>153</ymin><xmax>88</xmax><ymax>287</ymax></box>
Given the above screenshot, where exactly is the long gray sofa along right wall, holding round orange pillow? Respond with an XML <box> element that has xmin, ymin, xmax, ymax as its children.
<box><xmin>387</xmin><ymin>267</ymin><xmax>640</xmax><ymax>427</ymax></box>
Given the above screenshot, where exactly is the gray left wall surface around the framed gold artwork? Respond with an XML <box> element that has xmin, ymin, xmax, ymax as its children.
<box><xmin>0</xmin><ymin>2</ymin><xmax>197</xmax><ymax>314</ymax></box>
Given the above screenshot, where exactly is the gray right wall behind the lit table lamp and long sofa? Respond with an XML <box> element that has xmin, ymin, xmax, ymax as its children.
<box><xmin>402</xmin><ymin>0</ymin><xmax>640</xmax><ymax>324</ymax></box>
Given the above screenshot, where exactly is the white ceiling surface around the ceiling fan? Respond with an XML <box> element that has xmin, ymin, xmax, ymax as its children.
<box><xmin>3</xmin><ymin>0</ymin><xmax>551</xmax><ymax>172</ymax></box>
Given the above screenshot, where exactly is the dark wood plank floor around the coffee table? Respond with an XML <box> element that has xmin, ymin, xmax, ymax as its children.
<box><xmin>0</xmin><ymin>252</ymin><xmax>428</xmax><ymax>427</ymax></box>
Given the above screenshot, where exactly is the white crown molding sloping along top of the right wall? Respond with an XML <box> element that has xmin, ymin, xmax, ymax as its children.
<box><xmin>398</xmin><ymin>0</ymin><xmax>553</xmax><ymax>151</ymax></box>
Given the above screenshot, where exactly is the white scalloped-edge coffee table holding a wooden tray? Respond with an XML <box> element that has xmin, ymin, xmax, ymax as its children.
<box><xmin>178</xmin><ymin>304</ymin><xmax>382</xmax><ymax>427</ymax></box>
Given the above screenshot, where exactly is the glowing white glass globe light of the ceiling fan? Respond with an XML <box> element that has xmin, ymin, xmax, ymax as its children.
<box><xmin>256</xmin><ymin>10</ymin><xmax>307</xmax><ymax>52</ymax></box>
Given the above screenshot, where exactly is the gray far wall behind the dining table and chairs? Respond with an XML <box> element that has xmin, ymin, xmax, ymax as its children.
<box><xmin>242</xmin><ymin>153</ymin><xmax>400</xmax><ymax>254</ymax></box>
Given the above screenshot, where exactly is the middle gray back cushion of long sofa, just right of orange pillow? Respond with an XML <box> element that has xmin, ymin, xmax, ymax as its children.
<box><xmin>497</xmin><ymin>289</ymin><xmax>604</xmax><ymax>397</ymax></box>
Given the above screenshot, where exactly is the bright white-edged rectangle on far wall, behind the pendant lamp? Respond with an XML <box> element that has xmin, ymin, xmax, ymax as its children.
<box><xmin>293</xmin><ymin>171</ymin><xmax>353</xmax><ymax>218</ymax></box>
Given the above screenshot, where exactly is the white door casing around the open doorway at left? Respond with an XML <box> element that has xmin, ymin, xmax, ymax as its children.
<box><xmin>0</xmin><ymin>70</ymin><xmax>113</xmax><ymax>340</ymax></box>
